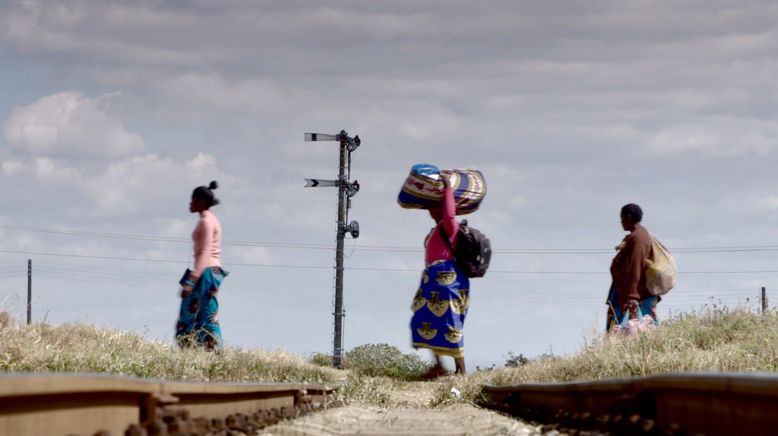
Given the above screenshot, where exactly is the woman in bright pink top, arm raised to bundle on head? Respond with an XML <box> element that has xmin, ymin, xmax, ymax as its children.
<box><xmin>411</xmin><ymin>174</ymin><xmax>470</xmax><ymax>377</ymax></box>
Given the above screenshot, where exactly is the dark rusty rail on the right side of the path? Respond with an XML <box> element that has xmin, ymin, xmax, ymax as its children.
<box><xmin>483</xmin><ymin>373</ymin><xmax>778</xmax><ymax>435</ymax></box>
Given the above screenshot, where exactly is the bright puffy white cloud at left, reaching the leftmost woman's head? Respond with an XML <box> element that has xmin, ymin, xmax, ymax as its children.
<box><xmin>0</xmin><ymin>92</ymin><xmax>224</xmax><ymax>217</ymax></box>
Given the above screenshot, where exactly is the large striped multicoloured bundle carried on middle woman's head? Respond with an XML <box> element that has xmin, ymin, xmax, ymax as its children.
<box><xmin>397</xmin><ymin>164</ymin><xmax>486</xmax><ymax>215</ymax></box>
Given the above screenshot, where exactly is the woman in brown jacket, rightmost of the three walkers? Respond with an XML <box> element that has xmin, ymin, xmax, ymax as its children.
<box><xmin>606</xmin><ymin>203</ymin><xmax>659</xmax><ymax>331</ymax></box>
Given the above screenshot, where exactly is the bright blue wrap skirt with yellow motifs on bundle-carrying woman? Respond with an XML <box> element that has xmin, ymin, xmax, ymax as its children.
<box><xmin>411</xmin><ymin>260</ymin><xmax>470</xmax><ymax>358</ymax></box>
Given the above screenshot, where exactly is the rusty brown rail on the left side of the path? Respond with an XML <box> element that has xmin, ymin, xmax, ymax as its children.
<box><xmin>0</xmin><ymin>374</ymin><xmax>338</xmax><ymax>436</ymax></box>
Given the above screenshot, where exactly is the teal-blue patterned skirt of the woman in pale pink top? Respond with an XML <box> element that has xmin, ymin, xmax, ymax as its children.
<box><xmin>176</xmin><ymin>267</ymin><xmax>228</xmax><ymax>350</ymax></box>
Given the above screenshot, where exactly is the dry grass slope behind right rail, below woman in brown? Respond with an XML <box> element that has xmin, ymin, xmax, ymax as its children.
<box><xmin>433</xmin><ymin>309</ymin><xmax>778</xmax><ymax>405</ymax></box>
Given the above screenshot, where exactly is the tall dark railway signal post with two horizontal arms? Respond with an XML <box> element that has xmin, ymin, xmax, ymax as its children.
<box><xmin>305</xmin><ymin>130</ymin><xmax>361</xmax><ymax>368</ymax></box>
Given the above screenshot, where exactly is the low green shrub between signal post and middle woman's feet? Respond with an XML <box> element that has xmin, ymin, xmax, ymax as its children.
<box><xmin>343</xmin><ymin>344</ymin><xmax>432</xmax><ymax>380</ymax></box>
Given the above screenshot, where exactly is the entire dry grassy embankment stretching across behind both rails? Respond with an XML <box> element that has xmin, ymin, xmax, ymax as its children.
<box><xmin>0</xmin><ymin>309</ymin><xmax>778</xmax><ymax>406</ymax></box>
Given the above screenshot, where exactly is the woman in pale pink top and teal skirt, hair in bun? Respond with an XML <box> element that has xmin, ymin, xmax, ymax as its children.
<box><xmin>176</xmin><ymin>181</ymin><xmax>227</xmax><ymax>350</ymax></box>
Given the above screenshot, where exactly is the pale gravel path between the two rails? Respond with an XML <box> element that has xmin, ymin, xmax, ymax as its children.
<box><xmin>260</xmin><ymin>383</ymin><xmax>541</xmax><ymax>436</ymax></box>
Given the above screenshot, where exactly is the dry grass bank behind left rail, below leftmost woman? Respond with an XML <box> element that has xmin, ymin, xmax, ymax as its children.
<box><xmin>0</xmin><ymin>316</ymin><xmax>345</xmax><ymax>383</ymax></box>
